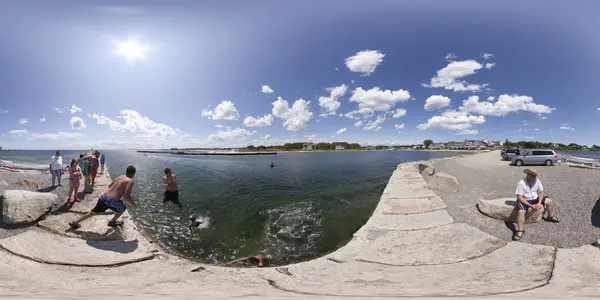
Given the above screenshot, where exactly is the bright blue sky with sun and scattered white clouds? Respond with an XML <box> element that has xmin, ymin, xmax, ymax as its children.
<box><xmin>0</xmin><ymin>0</ymin><xmax>600</xmax><ymax>149</ymax></box>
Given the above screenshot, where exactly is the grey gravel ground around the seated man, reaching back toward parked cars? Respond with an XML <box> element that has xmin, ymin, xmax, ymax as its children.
<box><xmin>434</xmin><ymin>151</ymin><xmax>600</xmax><ymax>248</ymax></box>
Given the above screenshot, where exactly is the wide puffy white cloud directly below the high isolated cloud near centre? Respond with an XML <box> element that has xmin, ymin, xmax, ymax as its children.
<box><xmin>350</xmin><ymin>87</ymin><xmax>410</xmax><ymax>111</ymax></box>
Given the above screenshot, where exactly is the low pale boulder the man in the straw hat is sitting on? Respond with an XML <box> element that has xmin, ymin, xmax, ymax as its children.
<box><xmin>477</xmin><ymin>198</ymin><xmax>542</xmax><ymax>223</ymax></box>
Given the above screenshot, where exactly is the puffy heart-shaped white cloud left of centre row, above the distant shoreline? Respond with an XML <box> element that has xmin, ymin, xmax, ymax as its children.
<box><xmin>272</xmin><ymin>97</ymin><xmax>313</xmax><ymax>131</ymax></box>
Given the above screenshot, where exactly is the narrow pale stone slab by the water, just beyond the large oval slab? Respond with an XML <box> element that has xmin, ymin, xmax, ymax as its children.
<box><xmin>354</xmin><ymin>210</ymin><xmax>453</xmax><ymax>238</ymax></box>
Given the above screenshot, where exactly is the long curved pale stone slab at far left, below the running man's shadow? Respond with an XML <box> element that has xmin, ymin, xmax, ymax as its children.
<box><xmin>0</xmin><ymin>230</ymin><xmax>154</xmax><ymax>267</ymax></box>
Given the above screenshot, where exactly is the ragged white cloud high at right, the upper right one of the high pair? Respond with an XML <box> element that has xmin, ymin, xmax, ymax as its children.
<box><xmin>422</xmin><ymin>60</ymin><xmax>483</xmax><ymax>92</ymax></box>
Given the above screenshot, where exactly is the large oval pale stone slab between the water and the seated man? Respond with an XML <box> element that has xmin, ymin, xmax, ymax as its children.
<box><xmin>355</xmin><ymin>223</ymin><xmax>506</xmax><ymax>266</ymax></box>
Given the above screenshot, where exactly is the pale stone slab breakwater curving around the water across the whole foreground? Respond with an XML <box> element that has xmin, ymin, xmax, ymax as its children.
<box><xmin>0</xmin><ymin>158</ymin><xmax>600</xmax><ymax>299</ymax></box>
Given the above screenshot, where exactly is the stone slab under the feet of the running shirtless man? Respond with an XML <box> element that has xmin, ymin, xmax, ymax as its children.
<box><xmin>38</xmin><ymin>213</ymin><xmax>137</xmax><ymax>241</ymax></box>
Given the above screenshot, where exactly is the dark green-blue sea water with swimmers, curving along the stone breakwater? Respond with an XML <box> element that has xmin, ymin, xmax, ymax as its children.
<box><xmin>0</xmin><ymin>151</ymin><xmax>457</xmax><ymax>264</ymax></box>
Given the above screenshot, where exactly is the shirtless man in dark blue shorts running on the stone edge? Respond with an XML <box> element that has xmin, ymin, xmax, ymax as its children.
<box><xmin>69</xmin><ymin>166</ymin><xmax>136</xmax><ymax>229</ymax></box>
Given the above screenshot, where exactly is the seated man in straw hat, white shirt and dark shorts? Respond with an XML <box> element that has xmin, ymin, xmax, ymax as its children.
<box><xmin>513</xmin><ymin>168</ymin><xmax>560</xmax><ymax>241</ymax></box>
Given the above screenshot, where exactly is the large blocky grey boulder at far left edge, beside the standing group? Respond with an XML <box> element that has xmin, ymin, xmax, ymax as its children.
<box><xmin>1</xmin><ymin>190</ymin><xmax>60</xmax><ymax>224</ymax></box>
